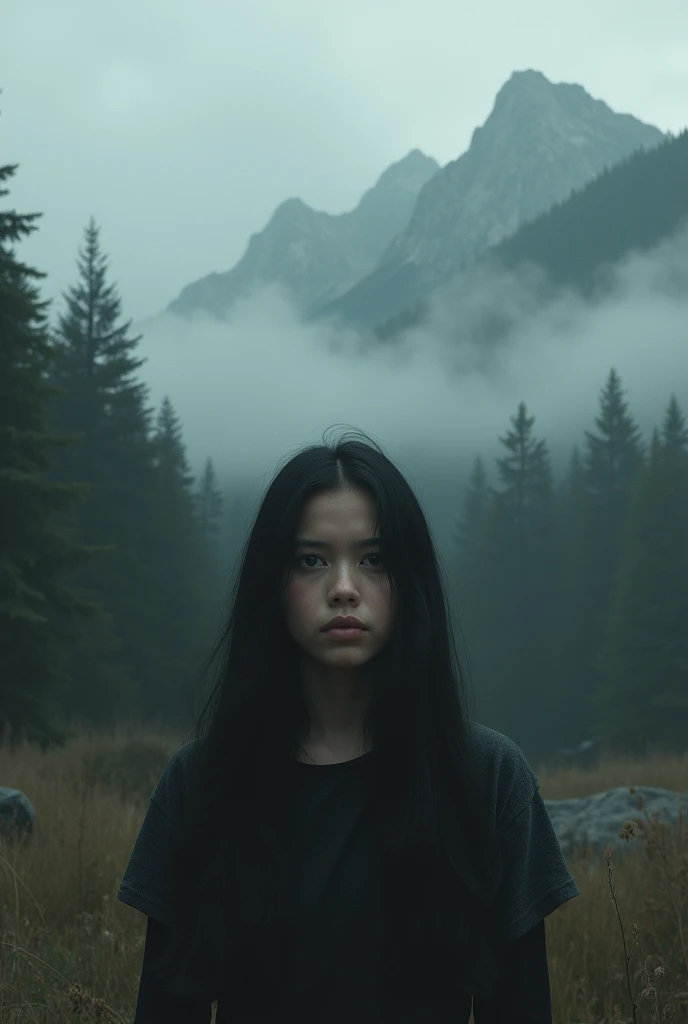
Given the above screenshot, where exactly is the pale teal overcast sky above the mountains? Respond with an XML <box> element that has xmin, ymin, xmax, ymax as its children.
<box><xmin>0</xmin><ymin>0</ymin><xmax>688</xmax><ymax>319</ymax></box>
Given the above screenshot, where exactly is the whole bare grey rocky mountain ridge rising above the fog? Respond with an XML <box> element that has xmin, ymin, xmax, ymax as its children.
<box><xmin>163</xmin><ymin>70</ymin><xmax>664</xmax><ymax>327</ymax></box>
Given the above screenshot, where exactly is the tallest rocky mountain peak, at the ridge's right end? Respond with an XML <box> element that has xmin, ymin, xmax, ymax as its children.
<box><xmin>319</xmin><ymin>69</ymin><xmax>663</xmax><ymax>323</ymax></box>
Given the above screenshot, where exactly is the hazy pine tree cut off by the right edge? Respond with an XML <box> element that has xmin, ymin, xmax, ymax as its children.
<box><xmin>593</xmin><ymin>396</ymin><xmax>688</xmax><ymax>754</ymax></box>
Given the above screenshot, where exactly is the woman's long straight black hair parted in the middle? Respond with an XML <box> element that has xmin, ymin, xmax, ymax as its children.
<box><xmin>151</xmin><ymin>432</ymin><xmax>500</xmax><ymax>1013</ymax></box>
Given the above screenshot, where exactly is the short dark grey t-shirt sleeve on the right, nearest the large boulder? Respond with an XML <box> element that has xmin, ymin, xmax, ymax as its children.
<box><xmin>497</xmin><ymin>769</ymin><xmax>581</xmax><ymax>942</ymax></box>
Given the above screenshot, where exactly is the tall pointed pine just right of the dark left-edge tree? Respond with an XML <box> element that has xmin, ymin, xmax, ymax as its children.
<box><xmin>51</xmin><ymin>218</ymin><xmax>156</xmax><ymax>724</ymax></box>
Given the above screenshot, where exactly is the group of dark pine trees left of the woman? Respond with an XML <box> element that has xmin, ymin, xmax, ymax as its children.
<box><xmin>0</xmin><ymin>166</ymin><xmax>247</xmax><ymax>743</ymax></box>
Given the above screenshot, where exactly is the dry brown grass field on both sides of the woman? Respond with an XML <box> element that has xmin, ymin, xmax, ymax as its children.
<box><xmin>0</xmin><ymin>729</ymin><xmax>688</xmax><ymax>1024</ymax></box>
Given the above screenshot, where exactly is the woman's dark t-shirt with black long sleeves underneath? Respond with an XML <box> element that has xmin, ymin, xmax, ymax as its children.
<box><xmin>118</xmin><ymin>723</ymin><xmax>579</xmax><ymax>1024</ymax></box>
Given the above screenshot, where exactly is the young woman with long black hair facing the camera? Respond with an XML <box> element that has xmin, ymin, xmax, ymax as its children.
<box><xmin>118</xmin><ymin>428</ymin><xmax>579</xmax><ymax>1024</ymax></box>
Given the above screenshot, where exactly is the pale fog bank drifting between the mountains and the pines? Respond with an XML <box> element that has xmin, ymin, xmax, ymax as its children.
<box><xmin>133</xmin><ymin>222</ymin><xmax>688</xmax><ymax>553</ymax></box>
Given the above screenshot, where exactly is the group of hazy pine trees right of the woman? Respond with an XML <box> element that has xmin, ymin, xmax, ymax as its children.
<box><xmin>452</xmin><ymin>378</ymin><xmax>688</xmax><ymax>762</ymax></box>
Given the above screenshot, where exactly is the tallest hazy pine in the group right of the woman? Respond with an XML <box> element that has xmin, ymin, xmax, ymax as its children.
<box><xmin>561</xmin><ymin>368</ymin><xmax>644</xmax><ymax>743</ymax></box>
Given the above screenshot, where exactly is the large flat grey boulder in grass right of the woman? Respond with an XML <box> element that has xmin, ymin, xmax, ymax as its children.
<box><xmin>545</xmin><ymin>785</ymin><xmax>688</xmax><ymax>872</ymax></box>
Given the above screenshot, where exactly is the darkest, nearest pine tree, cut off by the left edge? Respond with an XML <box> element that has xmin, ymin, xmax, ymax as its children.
<box><xmin>0</xmin><ymin>165</ymin><xmax>99</xmax><ymax>745</ymax></box>
